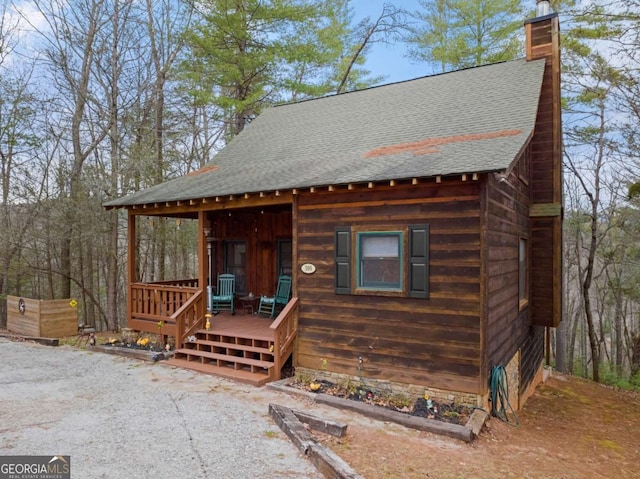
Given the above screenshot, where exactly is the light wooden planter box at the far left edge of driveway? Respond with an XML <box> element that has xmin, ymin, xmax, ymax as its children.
<box><xmin>7</xmin><ymin>296</ymin><xmax>78</xmax><ymax>338</ymax></box>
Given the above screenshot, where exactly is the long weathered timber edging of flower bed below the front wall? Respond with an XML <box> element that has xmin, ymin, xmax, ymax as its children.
<box><xmin>267</xmin><ymin>378</ymin><xmax>489</xmax><ymax>442</ymax></box>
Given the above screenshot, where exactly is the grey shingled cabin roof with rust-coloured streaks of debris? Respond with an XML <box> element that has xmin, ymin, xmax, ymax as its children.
<box><xmin>105</xmin><ymin>59</ymin><xmax>545</xmax><ymax>207</ymax></box>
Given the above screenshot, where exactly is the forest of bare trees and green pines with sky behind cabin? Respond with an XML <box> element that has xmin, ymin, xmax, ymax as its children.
<box><xmin>0</xmin><ymin>0</ymin><xmax>640</xmax><ymax>388</ymax></box>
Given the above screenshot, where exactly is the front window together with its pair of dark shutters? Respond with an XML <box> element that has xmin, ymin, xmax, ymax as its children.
<box><xmin>334</xmin><ymin>225</ymin><xmax>429</xmax><ymax>298</ymax></box>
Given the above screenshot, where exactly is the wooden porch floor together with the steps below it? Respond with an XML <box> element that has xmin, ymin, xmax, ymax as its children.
<box><xmin>168</xmin><ymin>312</ymin><xmax>276</xmax><ymax>386</ymax></box>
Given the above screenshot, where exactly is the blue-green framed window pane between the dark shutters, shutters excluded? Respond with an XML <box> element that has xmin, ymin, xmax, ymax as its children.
<box><xmin>357</xmin><ymin>232</ymin><xmax>402</xmax><ymax>290</ymax></box>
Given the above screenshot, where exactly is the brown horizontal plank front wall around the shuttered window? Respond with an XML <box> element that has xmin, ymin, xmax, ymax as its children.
<box><xmin>294</xmin><ymin>181</ymin><xmax>484</xmax><ymax>394</ymax></box>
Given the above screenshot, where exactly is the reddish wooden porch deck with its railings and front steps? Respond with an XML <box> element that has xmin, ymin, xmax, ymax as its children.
<box><xmin>130</xmin><ymin>283</ymin><xmax>298</xmax><ymax>386</ymax></box>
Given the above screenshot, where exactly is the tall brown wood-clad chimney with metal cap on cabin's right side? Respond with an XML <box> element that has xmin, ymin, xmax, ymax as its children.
<box><xmin>525</xmin><ymin>0</ymin><xmax>563</xmax><ymax>327</ymax></box>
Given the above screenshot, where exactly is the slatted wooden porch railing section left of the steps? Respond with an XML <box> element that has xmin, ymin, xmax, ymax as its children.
<box><xmin>128</xmin><ymin>280</ymin><xmax>204</xmax><ymax>340</ymax></box>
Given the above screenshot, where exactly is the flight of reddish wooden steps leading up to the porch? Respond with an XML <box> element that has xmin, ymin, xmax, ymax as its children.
<box><xmin>167</xmin><ymin>329</ymin><xmax>274</xmax><ymax>386</ymax></box>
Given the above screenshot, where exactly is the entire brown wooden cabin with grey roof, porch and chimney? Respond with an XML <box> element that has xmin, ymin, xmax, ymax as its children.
<box><xmin>106</xmin><ymin>14</ymin><xmax>562</xmax><ymax>407</ymax></box>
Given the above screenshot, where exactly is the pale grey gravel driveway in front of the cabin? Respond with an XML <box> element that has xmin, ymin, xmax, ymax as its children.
<box><xmin>0</xmin><ymin>338</ymin><xmax>322</xmax><ymax>479</ymax></box>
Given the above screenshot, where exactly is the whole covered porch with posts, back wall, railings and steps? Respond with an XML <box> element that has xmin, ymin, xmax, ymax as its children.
<box><xmin>127</xmin><ymin>202</ymin><xmax>298</xmax><ymax>385</ymax></box>
